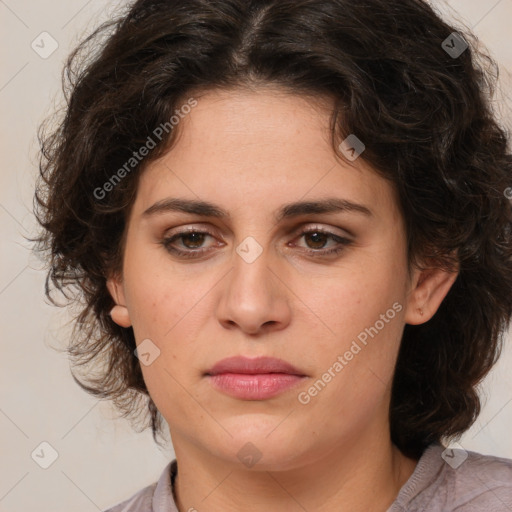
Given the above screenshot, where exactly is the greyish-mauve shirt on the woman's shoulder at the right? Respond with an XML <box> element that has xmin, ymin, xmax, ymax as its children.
<box><xmin>390</xmin><ymin>444</ymin><xmax>512</xmax><ymax>512</ymax></box>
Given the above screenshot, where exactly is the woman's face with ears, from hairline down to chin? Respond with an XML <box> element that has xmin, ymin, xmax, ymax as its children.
<box><xmin>108</xmin><ymin>89</ymin><xmax>453</xmax><ymax>469</ymax></box>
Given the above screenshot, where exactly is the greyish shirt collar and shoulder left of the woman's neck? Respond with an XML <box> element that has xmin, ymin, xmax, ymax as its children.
<box><xmin>104</xmin><ymin>459</ymin><xmax>178</xmax><ymax>512</ymax></box>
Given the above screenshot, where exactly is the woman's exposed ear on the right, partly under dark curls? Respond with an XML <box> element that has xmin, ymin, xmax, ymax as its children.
<box><xmin>404</xmin><ymin>262</ymin><xmax>459</xmax><ymax>325</ymax></box>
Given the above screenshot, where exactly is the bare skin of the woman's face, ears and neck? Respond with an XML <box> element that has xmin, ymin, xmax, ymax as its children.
<box><xmin>108</xmin><ymin>87</ymin><xmax>456</xmax><ymax>512</ymax></box>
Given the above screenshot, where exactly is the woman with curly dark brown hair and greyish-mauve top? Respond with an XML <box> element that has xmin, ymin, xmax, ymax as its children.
<box><xmin>36</xmin><ymin>0</ymin><xmax>512</xmax><ymax>512</ymax></box>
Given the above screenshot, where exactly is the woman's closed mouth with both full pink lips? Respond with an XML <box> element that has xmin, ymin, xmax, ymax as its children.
<box><xmin>205</xmin><ymin>356</ymin><xmax>307</xmax><ymax>400</ymax></box>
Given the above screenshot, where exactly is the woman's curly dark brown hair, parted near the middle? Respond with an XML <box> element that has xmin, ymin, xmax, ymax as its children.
<box><xmin>33</xmin><ymin>0</ymin><xmax>512</xmax><ymax>457</ymax></box>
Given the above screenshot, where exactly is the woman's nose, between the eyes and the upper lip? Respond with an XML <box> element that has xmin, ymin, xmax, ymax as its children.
<box><xmin>216</xmin><ymin>244</ymin><xmax>291</xmax><ymax>335</ymax></box>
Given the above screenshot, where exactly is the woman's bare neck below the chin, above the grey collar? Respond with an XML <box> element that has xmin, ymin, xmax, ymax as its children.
<box><xmin>170</xmin><ymin>432</ymin><xmax>417</xmax><ymax>512</ymax></box>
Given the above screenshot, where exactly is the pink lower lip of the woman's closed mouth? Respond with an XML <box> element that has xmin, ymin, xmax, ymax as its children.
<box><xmin>208</xmin><ymin>373</ymin><xmax>304</xmax><ymax>400</ymax></box>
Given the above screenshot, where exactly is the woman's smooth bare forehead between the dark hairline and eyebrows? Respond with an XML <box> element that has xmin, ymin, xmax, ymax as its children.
<box><xmin>131</xmin><ymin>88</ymin><xmax>396</xmax><ymax>224</ymax></box>
